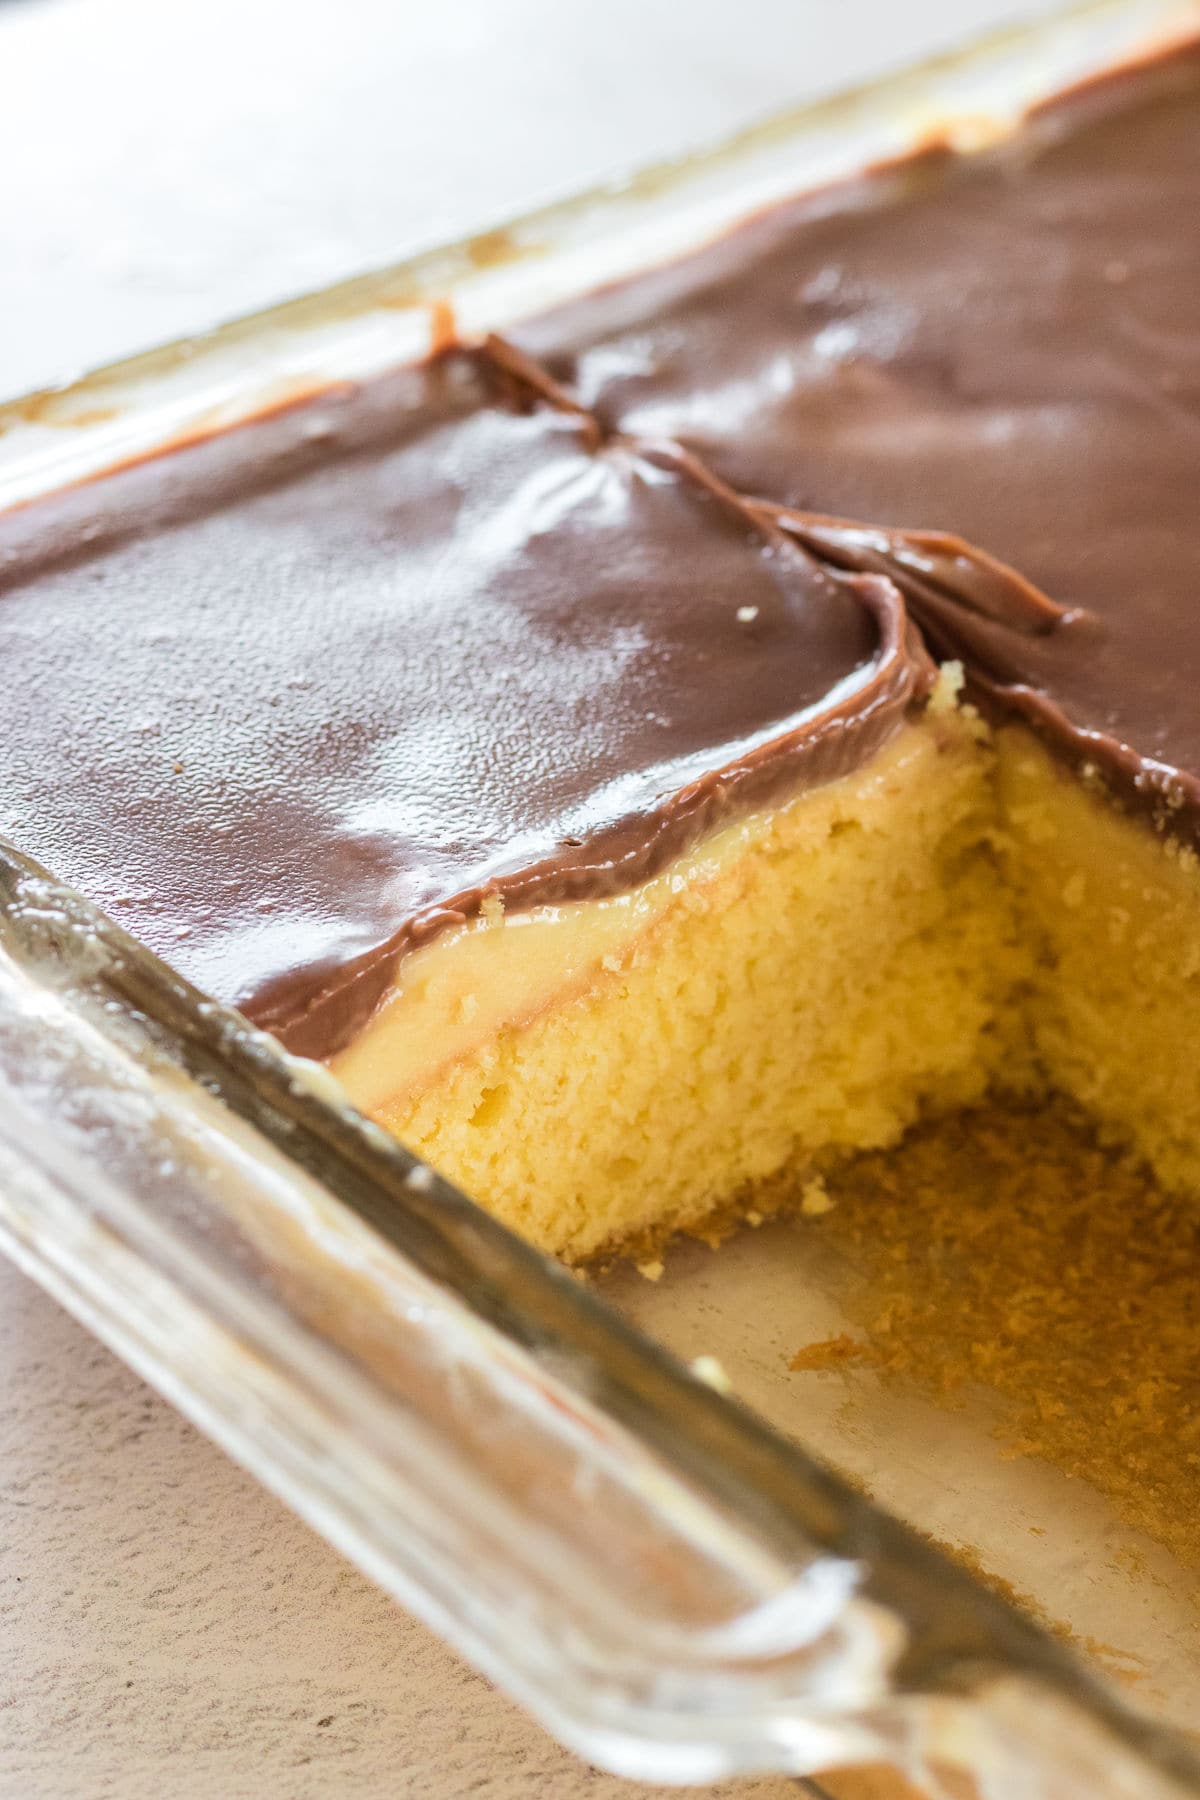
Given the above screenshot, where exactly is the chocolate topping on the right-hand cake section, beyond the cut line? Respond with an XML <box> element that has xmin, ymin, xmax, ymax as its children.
<box><xmin>518</xmin><ymin>45</ymin><xmax>1200</xmax><ymax>842</ymax></box>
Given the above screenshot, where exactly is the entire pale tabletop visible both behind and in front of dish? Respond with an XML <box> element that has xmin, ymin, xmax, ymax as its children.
<box><xmin>0</xmin><ymin>0</ymin><xmax>1038</xmax><ymax>1800</ymax></box>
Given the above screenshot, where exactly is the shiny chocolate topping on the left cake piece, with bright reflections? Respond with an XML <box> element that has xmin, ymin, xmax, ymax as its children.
<box><xmin>0</xmin><ymin>351</ymin><xmax>930</xmax><ymax>1055</ymax></box>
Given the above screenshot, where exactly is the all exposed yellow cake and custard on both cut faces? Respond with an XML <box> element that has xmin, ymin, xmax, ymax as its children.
<box><xmin>333</xmin><ymin>682</ymin><xmax>1200</xmax><ymax>1260</ymax></box>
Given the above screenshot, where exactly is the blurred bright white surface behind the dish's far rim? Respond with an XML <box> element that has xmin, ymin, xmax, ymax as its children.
<box><xmin>0</xmin><ymin>0</ymin><xmax>1061</xmax><ymax>396</ymax></box>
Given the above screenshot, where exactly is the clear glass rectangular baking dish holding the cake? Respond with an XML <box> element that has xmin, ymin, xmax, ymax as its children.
<box><xmin>0</xmin><ymin>0</ymin><xmax>1200</xmax><ymax>1800</ymax></box>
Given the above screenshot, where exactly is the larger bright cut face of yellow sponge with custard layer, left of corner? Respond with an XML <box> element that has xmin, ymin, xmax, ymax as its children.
<box><xmin>335</xmin><ymin>707</ymin><xmax>1031</xmax><ymax>1260</ymax></box>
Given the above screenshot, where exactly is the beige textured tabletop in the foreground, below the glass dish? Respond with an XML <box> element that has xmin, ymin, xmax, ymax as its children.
<box><xmin>0</xmin><ymin>1262</ymin><xmax>928</xmax><ymax>1800</ymax></box>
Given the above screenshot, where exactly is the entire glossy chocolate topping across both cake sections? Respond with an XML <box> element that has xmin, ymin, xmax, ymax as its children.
<box><xmin>0</xmin><ymin>42</ymin><xmax>1200</xmax><ymax>1055</ymax></box>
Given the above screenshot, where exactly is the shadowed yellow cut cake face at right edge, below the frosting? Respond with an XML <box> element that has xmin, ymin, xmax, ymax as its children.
<box><xmin>997</xmin><ymin>727</ymin><xmax>1200</xmax><ymax>1193</ymax></box>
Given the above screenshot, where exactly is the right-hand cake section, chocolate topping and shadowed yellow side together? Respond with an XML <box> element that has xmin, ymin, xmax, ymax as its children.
<box><xmin>520</xmin><ymin>43</ymin><xmax>1200</xmax><ymax>1216</ymax></box>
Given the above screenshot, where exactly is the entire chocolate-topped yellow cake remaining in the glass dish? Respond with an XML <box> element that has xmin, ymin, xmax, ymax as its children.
<box><xmin>0</xmin><ymin>38</ymin><xmax>1200</xmax><ymax>1260</ymax></box>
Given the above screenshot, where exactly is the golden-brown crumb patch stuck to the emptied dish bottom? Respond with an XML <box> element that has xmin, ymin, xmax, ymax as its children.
<box><xmin>790</xmin><ymin>1103</ymin><xmax>1200</xmax><ymax>1568</ymax></box>
